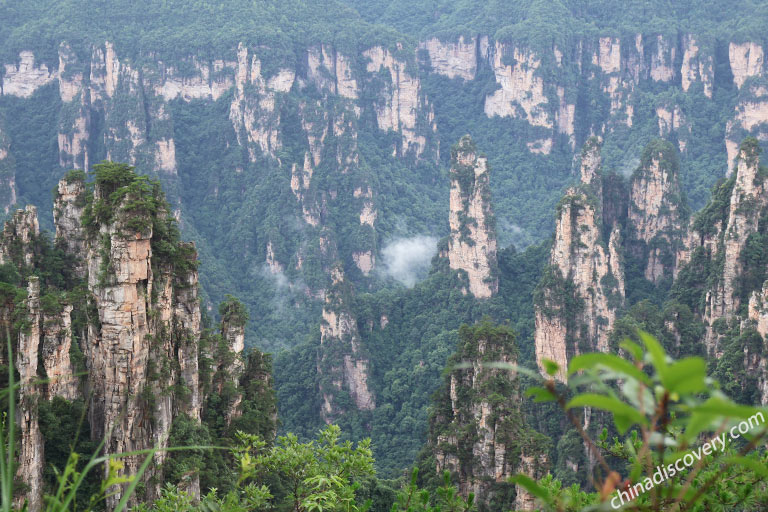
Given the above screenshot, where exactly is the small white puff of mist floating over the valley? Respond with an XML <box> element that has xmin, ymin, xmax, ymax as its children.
<box><xmin>379</xmin><ymin>235</ymin><xmax>437</xmax><ymax>288</ymax></box>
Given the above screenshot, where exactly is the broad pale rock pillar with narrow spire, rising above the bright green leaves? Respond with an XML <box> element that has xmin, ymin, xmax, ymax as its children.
<box><xmin>534</xmin><ymin>138</ymin><xmax>624</xmax><ymax>380</ymax></box>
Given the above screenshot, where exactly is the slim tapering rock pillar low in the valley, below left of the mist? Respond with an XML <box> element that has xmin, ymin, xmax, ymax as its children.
<box><xmin>317</xmin><ymin>265</ymin><xmax>376</xmax><ymax>423</ymax></box>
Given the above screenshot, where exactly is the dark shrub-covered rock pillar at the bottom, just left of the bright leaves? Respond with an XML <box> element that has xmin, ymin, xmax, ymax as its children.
<box><xmin>428</xmin><ymin>322</ymin><xmax>548</xmax><ymax>510</ymax></box>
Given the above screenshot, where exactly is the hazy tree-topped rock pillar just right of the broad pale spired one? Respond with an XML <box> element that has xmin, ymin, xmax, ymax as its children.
<box><xmin>628</xmin><ymin>140</ymin><xmax>688</xmax><ymax>283</ymax></box>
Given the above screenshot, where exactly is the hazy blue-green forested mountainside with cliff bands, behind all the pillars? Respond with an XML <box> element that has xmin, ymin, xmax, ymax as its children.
<box><xmin>0</xmin><ymin>1</ymin><xmax>766</xmax><ymax>354</ymax></box>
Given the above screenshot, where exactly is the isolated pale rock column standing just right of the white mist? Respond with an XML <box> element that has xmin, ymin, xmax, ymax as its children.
<box><xmin>448</xmin><ymin>135</ymin><xmax>499</xmax><ymax>299</ymax></box>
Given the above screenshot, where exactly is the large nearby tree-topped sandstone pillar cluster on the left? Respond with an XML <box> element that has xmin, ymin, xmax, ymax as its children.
<box><xmin>6</xmin><ymin>168</ymin><xmax>274</xmax><ymax>511</ymax></box>
